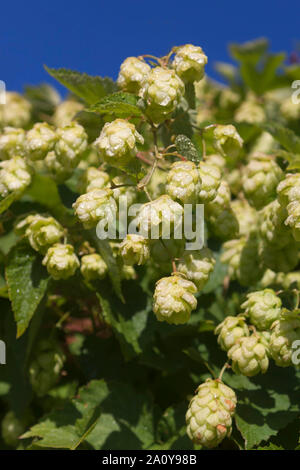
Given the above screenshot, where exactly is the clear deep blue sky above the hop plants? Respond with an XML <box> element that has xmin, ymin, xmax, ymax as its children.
<box><xmin>0</xmin><ymin>0</ymin><xmax>300</xmax><ymax>96</ymax></box>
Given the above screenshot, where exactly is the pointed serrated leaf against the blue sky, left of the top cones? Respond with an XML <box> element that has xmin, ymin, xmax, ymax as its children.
<box><xmin>45</xmin><ymin>65</ymin><xmax>117</xmax><ymax>104</ymax></box>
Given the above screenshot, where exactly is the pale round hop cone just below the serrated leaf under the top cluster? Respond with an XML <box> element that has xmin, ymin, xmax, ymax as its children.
<box><xmin>95</xmin><ymin>119</ymin><xmax>144</xmax><ymax>168</ymax></box>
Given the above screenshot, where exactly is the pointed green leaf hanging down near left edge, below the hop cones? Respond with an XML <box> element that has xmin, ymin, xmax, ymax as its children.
<box><xmin>5</xmin><ymin>241</ymin><xmax>50</xmax><ymax>337</ymax></box>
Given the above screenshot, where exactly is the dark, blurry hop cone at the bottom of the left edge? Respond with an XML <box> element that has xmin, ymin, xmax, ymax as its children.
<box><xmin>1</xmin><ymin>410</ymin><xmax>32</xmax><ymax>447</ymax></box>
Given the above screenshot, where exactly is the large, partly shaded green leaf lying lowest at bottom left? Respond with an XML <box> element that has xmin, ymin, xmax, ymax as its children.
<box><xmin>23</xmin><ymin>380</ymin><xmax>154</xmax><ymax>450</ymax></box>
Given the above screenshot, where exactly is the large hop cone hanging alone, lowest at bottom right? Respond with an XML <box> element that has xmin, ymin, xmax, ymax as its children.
<box><xmin>186</xmin><ymin>379</ymin><xmax>237</xmax><ymax>449</ymax></box>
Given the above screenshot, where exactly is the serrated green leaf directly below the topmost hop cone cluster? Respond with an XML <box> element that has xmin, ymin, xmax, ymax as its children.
<box><xmin>86</xmin><ymin>91</ymin><xmax>142</xmax><ymax>117</ymax></box>
